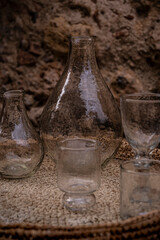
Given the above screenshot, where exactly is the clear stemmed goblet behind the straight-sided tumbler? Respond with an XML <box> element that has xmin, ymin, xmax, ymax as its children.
<box><xmin>120</xmin><ymin>93</ymin><xmax>160</xmax><ymax>159</ymax></box>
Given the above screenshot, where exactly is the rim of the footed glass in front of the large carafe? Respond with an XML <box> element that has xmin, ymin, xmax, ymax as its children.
<box><xmin>57</xmin><ymin>138</ymin><xmax>98</xmax><ymax>151</ymax></box>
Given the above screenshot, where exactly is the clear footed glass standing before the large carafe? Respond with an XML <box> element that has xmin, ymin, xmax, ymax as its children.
<box><xmin>57</xmin><ymin>138</ymin><xmax>101</xmax><ymax>211</ymax></box>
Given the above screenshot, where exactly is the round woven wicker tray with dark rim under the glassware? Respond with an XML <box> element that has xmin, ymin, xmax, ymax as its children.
<box><xmin>0</xmin><ymin>141</ymin><xmax>160</xmax><ymax>240</ymax></box>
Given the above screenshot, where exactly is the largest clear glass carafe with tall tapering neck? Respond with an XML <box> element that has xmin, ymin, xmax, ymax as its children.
<box><xmin>41</xmin><ymin>37</ymin><xmax>122</xmax><ymax>164</ymax></box>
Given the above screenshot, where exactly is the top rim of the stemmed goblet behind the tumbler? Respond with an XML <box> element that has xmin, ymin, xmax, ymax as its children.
<box><xmin>120</xmin><ymin>92</ymin><xmax>160</xmax><ymax>103</ymax></box>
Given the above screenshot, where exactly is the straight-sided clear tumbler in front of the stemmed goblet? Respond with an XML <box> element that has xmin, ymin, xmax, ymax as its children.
<box><xmin>120</xmin><ymin>159</ymin><xmax>160</xmax><ymax>219</ymax></box>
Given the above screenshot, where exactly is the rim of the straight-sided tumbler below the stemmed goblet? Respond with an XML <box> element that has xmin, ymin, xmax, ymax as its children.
<box><xmin>120</xmin><ymin>159</ymin><xmax>160</xmax><ymax>175</ymax></box>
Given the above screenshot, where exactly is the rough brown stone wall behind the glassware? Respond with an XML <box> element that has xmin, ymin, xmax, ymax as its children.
<box><xmin>0</xmin><ymin>0</ymin><xmax>160</xmax><ymax>126</ymax></box>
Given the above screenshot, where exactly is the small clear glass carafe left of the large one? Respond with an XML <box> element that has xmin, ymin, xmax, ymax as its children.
<box><xmin>0</xmin><ymin>90</ymin><xmax>44</xmax><ymax>178</ymax></box>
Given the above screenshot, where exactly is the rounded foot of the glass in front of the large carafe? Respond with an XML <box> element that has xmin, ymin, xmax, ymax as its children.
<box><xmin>63</xmin><ymin>193</ymin><xmax>96</xmax><ymax>211</ymax></box>
